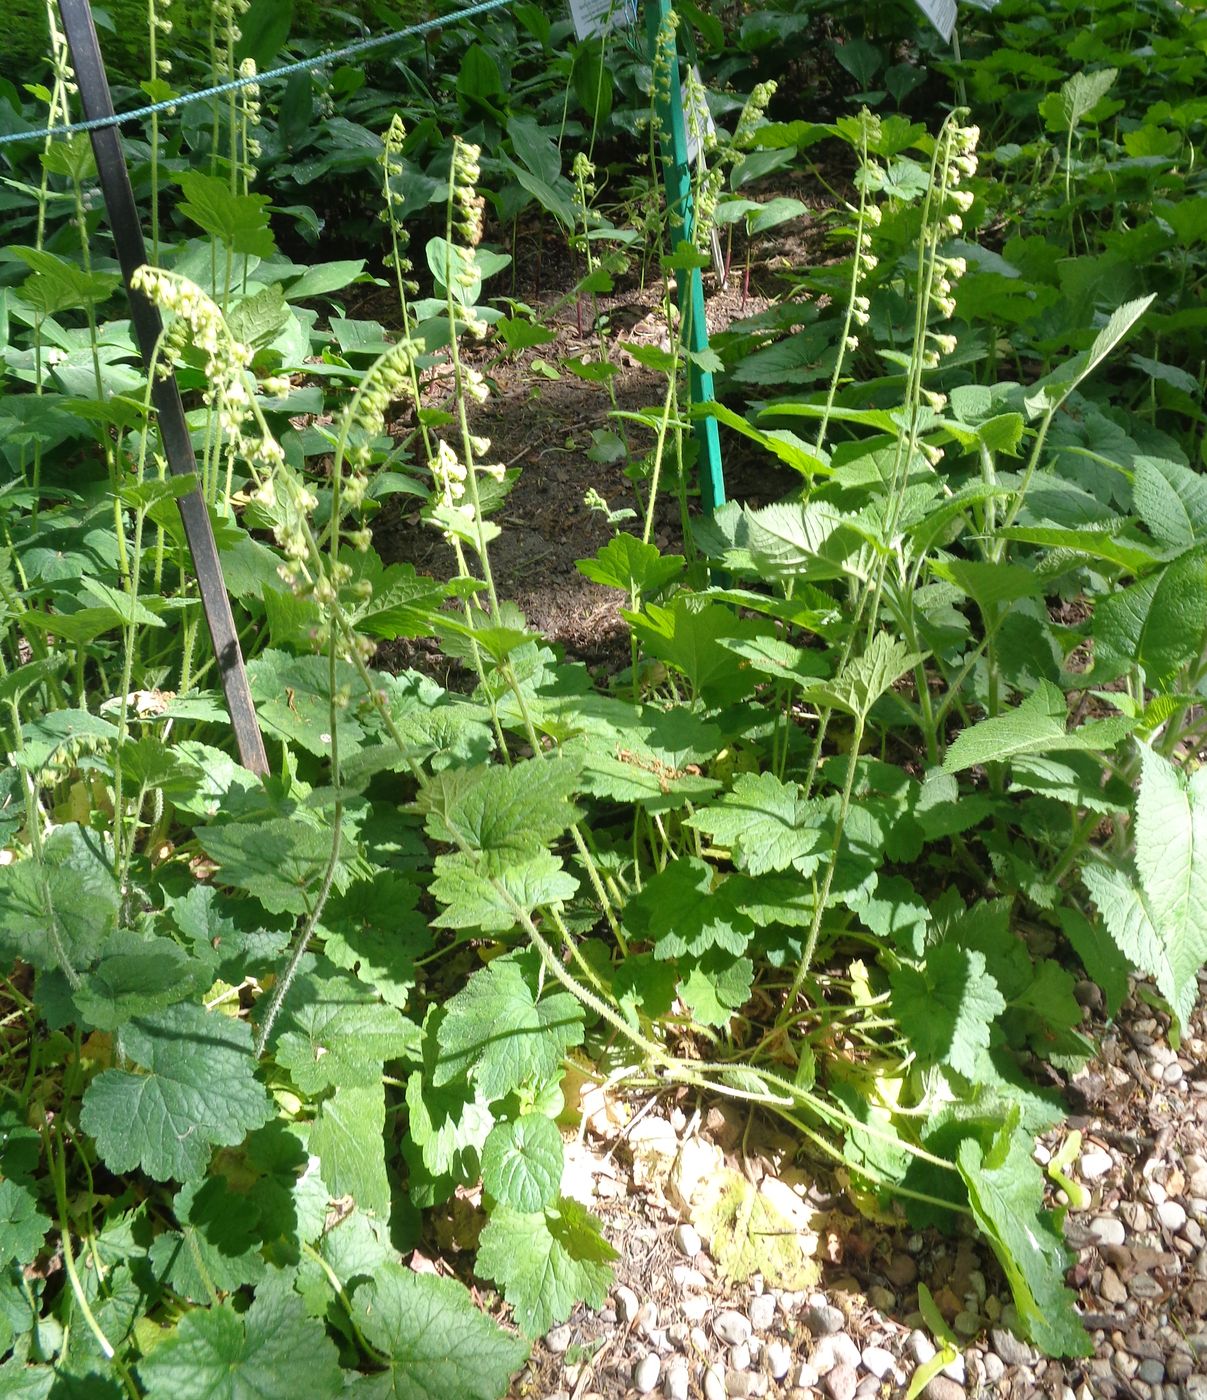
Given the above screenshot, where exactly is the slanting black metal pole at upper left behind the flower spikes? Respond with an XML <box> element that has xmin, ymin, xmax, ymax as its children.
<box><xmin>59</xmin><ymin>0</ymin><xmax>269</xmax><ymax>774</ymax></box>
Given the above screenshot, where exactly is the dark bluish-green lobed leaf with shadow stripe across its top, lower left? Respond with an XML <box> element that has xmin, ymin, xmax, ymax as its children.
<box><xmin>80</xmin><ymin>1004</ymin><xmax>272</xmax><ymax>1182</ymax></box>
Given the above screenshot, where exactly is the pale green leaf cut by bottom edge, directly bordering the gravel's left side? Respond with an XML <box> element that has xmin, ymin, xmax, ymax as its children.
<box><xmin>350</xmin><ymin>1263</ymin><xmax>528</xmax><ymax>1400</ymax></box>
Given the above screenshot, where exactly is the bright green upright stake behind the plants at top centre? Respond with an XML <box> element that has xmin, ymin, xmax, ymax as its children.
<box><xmin>646</xmin><ymin>0</ymin><xmax>725</xmax><ymax>515</ymax></box>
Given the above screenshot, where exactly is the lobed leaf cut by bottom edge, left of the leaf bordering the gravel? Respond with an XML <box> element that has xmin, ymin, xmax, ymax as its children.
<box><xmin>139</xmin><ymin>1285</ymin><xmax>343</xmax><ymax>1400</ymax></box>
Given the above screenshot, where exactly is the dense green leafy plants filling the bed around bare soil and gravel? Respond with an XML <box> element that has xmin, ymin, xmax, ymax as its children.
<box><xmin>0</xmin><ymin>0</ymin><xmax>1207</xmax><ymax>1400</ymax></box>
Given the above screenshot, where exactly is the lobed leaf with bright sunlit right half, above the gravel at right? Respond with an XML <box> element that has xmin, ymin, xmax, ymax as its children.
<box><xmin>889</xmin><ymin>944</ymin><xmax>1005</xmax><ymax>1079</ymax></box>
